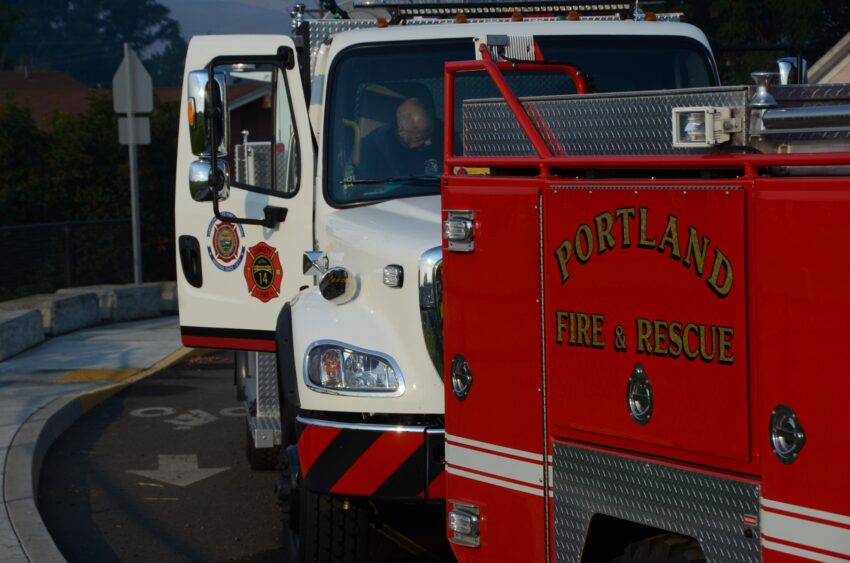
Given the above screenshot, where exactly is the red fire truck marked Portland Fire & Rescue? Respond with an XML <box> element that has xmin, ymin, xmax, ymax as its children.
<box><xmin>443</xmin><ymin>38</ymin><xmax>850</xmax><ymax>563</ymax></box>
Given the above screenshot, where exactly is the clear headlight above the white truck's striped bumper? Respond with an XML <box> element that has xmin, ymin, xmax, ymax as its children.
<box><xmin>305</xmin><ymin>342</ymin><xmax>404</xmax><ymax>396</ymax></box>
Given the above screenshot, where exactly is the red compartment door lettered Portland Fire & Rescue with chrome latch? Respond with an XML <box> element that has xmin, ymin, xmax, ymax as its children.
<box><xmin>543</xmin><ymin>183</ymin><xmax>750</xmax><ymax>471</ymax></box>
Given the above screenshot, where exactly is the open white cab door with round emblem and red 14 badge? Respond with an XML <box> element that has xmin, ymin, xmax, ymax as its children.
<box><xmin>175</xmin><ymin>35</ymin><xmax>314</xmax><ymax>351</ymax></box>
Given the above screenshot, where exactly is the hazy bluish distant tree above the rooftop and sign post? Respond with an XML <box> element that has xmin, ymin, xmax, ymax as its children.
<box><xmin>6</xmin><ymin>0</ymin><xmax>186</xmax><ymax>86</ymax></box>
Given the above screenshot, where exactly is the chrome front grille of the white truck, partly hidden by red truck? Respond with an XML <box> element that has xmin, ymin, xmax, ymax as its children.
<box><xmin>419</xmin><ymin>246</ymin><xmax>443</xmax><ymax>378</ymax></box>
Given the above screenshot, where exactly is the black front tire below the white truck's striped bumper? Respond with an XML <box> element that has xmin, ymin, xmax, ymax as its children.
<box><xmin>298</xmin><ymin>486</ymin><xmax>369</xmax><ymax>563</ymax></box>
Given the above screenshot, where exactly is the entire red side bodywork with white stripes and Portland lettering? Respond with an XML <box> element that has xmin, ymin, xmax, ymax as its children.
<box><xmin>443</xmin><ymin>176</ymin><xmax>850</xmax><ymax>562</ymax></box>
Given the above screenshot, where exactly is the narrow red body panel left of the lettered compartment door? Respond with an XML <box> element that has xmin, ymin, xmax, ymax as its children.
<box><xmin>443</xmin><ymin>182</ymin><xmax>548</xmax><ymax>561</ymax></box>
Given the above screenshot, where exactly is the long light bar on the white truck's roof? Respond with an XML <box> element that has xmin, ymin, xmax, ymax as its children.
<box><xmin>354</xmin><ymin>0</ymin><xmax>634</xmax><ymax>16</ymax></box>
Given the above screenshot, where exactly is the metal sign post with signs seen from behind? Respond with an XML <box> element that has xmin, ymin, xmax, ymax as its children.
<box><xmin>112</xmin><ymin>43</ymin><xmax>153</xmax><ymax>285</ymax></box>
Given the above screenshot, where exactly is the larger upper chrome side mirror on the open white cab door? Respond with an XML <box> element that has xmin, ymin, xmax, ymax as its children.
<box><xmin>186</xmin><ymin>70</ymin><xmax>225</xmax><ymax>158</ymax></box>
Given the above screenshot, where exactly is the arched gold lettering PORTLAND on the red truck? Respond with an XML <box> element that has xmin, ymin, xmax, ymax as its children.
<box><xmin>555</xmin><ymin>207</ymin><xmax>735</xmax><ymax>298</ymax></box>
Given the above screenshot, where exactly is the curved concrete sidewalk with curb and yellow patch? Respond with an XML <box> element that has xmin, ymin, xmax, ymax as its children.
<box><xmin>0</xmin><ymin>315</ymin><xmax>188</xmax><ymax>563</ymax></box>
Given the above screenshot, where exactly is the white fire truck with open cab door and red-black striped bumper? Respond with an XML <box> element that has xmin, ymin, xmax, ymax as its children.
<box><xmin>175</xmin><ymin>1</ymin><xmax>760</xmax><ymax>560</ymax></box>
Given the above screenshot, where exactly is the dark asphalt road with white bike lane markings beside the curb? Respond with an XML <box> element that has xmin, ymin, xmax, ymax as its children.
<box><xmin>39</xmin><ymin>352</ymin><xmax>452</xmax><ymax>563</ymax></box>
